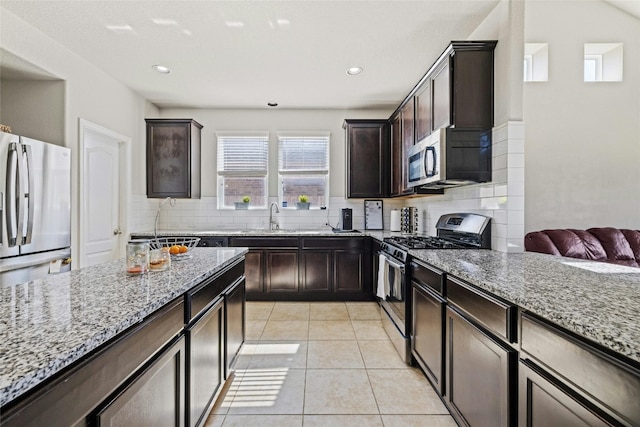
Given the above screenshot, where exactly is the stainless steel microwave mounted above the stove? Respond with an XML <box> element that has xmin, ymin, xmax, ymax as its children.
<box><xmin>407</xmin><ymin>128</ymin><xmax>491</xmax><ymax>188</ymax></box>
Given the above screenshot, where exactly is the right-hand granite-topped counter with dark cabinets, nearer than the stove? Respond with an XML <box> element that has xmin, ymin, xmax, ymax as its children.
<box><xmin>410</xmin><ymin>250</ymin><xmax>640</xmax><ymax>426</ymax></box>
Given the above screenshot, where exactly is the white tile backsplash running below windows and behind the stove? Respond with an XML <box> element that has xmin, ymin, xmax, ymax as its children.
<box><xmin>129</xmin><ymin>122</ymin><xmax>524</xmax><ymax>252</ymax></box>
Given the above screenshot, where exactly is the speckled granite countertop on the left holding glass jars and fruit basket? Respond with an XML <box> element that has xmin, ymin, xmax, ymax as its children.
<box><xmin>0</xmin><ymin>248</ymin><xmax>247</xmax><ymax>405</ymax></box>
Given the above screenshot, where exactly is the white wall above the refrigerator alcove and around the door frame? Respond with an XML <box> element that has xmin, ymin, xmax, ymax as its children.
<box><xmin>0</xmin><ymin>6</ymin><xmax>157</xmax><ymax>264</ymax></box>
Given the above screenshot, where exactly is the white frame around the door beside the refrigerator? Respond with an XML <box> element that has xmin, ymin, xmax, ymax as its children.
<box><xmin>76</xmin><ymin>118</ymin><xmax>132</xmax><ymax>268</ymax></box>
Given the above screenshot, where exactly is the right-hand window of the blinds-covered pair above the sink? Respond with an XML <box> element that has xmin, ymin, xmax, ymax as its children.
<box><xmin>278</xmin><ymin>132</ymin><xmax>330</xmax><ymax>209</ymax></box>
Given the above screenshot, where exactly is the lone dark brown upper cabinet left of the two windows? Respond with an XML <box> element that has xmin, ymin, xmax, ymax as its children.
<box><xmin>145</xmin><ymin>119</ymin><xmax>202</xmax><ymax>199</ymax></box>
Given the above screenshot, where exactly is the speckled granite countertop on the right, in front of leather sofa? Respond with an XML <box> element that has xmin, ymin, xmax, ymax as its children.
<box><xmin>409</xmin><ymin>249</ymin><xmax>640</xmax><ymax>362</ymax></box>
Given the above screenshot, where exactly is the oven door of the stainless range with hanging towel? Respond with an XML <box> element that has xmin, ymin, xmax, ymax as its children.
<box><xmin>380</xmin><ymin>252</ymin><xmax>407</xmax><ymax>333</ymax></box>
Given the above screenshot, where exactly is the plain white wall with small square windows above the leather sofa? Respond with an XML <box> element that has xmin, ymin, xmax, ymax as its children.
<box><xmin>524</xmin><ymin>1</ymin><xmax>640</xmax><ymax>231</ymax></box>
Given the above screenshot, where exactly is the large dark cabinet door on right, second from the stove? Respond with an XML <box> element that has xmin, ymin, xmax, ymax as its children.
<box><xmin>446</xmin><ymin>307</ymin><xmax>517</xmax><ymax>427</ymax></box>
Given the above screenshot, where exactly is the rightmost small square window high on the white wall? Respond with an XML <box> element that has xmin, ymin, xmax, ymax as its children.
<box><xmin>584</xmin><ymin>43</ymin><xmax>623</xmax><ymax>82</ymax></box>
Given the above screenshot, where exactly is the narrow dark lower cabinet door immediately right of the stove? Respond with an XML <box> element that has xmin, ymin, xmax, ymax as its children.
<box><xmin>411</xmin><ymin>284</ymin><xmax>445</xmax><ymax>396</ymax></box>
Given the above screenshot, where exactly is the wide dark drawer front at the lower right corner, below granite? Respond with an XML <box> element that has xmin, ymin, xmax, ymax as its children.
<box><xmin>521</xmin><ymin>313</ymin><xmax>640</xmax><ymax>425</ymax></box>
